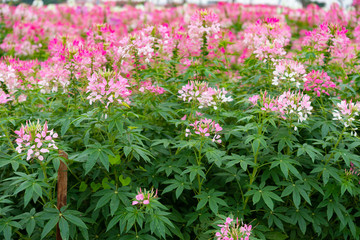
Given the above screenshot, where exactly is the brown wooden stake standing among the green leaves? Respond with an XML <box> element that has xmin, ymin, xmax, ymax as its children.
<box><xmin>56</xmin><ymin>151</ymin><xmax>68</xmax><ymax>240</ymax></box>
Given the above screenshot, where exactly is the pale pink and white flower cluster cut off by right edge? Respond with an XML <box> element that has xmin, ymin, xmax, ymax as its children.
<box><xmin>333</xmin><ymin>100</ymin><xmax>360</xmax><ymax>135</ymax></box>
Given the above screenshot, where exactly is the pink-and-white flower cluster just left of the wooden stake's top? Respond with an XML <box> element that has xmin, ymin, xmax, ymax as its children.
<box><xmin>15</xmin><ymin>121</ymin><xmax>58</xmax><ymax>161</ymax></box>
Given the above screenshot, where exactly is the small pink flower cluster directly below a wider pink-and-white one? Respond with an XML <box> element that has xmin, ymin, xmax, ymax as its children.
<box><xmin>185</xmin><ymin>118</ymin><xmax>222</xmax><ymax>143</ymax></box>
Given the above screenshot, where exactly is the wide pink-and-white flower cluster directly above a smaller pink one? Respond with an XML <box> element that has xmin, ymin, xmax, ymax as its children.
<box><xmin>178</xmin><ymin>81</ymin><xmax>233</xmax><ymax>110</ymax></box>
